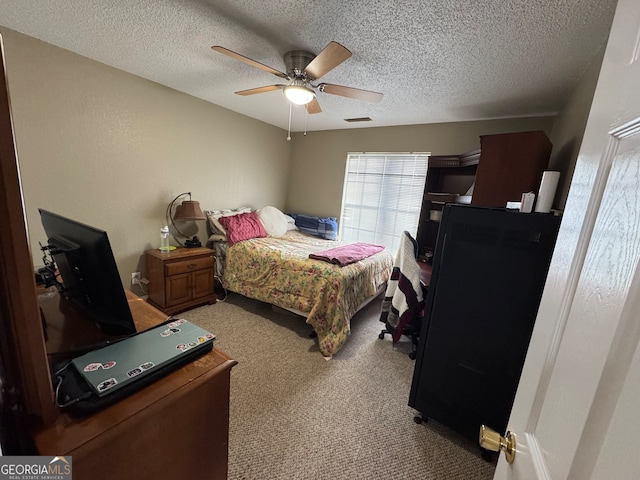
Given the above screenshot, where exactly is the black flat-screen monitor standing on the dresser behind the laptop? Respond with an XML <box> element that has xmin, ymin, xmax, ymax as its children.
<box><xmin>38</xmin><ymin>208</ymin><xmax>136</xmax><ymax>335</ymax></box>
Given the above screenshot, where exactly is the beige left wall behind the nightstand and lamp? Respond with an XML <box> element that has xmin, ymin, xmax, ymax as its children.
<box><xmin>0</xmin><ymin>28</ymin><xmax>291</xmax><ymax>286</ymax></box>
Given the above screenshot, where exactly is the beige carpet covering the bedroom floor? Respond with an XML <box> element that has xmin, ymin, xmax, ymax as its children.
<box><xmin>179</xmin><ymin>293</ymin><xmax>494</xmax><ymax>480</ymax></box>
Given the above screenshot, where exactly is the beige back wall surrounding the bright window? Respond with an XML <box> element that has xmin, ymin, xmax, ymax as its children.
<box><xmin>287</xmin><ymin>117</ymin><xmax>554</xmax><ymax>217</ymax></box>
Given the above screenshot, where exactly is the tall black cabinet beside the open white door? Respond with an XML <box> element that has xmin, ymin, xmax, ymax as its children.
<box><xmin>409</xmin><ymin>204</ymin><xmax>560</xmax><ymax>439</ymax></box>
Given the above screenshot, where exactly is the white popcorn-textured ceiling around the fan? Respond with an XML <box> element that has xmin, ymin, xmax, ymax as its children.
<box><xmin>0</xmin><ymin>0</ymin><xmax>616</xmax><ymax>131</ymax></box>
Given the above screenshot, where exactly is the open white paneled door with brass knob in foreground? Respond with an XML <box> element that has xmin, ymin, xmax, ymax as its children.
<box><xmin>488</xmin><ymin>0</ymin><xmax>640</xmax><ymax>480</ymax></box>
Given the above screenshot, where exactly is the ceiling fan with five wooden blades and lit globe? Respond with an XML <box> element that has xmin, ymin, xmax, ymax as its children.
<box><xmin>211</xmin><ymin>42</ymin><xmax>382</xmax><ymax>113</ymax></box>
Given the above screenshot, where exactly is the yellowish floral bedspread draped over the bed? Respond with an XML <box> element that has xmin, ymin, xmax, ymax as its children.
<box><xmin>222</xmin><ymin>231</ymin><xmax>393</xmax><ymax>356</ymax></box>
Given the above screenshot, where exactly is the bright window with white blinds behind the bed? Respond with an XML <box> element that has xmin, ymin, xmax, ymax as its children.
<box><xmin>339</xmin><ymin>153</ymin><xmax>429</xmax><ymax>255</ymax></box>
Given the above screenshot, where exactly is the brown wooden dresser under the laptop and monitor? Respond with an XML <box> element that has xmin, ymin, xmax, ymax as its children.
<box><xmin>33</xmin><ymin>292</ymin><xmax>237</xmax><ymax>480</ymax></box>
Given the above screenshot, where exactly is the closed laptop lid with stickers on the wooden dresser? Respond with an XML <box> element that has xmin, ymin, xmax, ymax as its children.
<box><xmin>71</xmin><ymin>319</ymin><xmax>216</xmax><ymax>396</ymax></box>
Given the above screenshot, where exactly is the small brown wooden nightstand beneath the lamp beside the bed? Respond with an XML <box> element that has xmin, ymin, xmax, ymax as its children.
<box><xmin>146</xmin><ymin>247</ymin><xmax>216</xmax><ymax>315</ymax></box>
